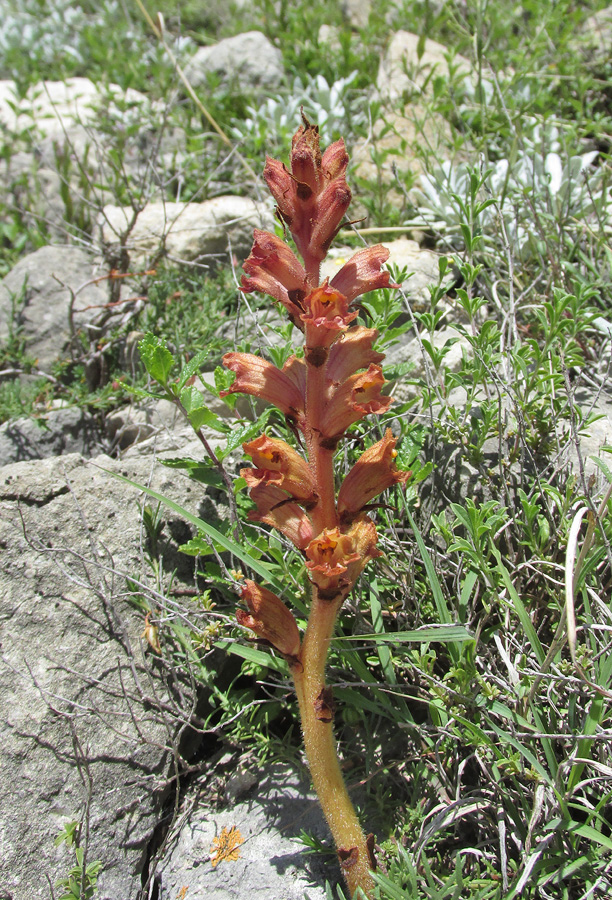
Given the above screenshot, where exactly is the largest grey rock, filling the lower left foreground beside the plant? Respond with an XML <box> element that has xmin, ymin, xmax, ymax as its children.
<box><xmin>0</xmin><ymin>455</ymin><xmax>213</xmax><ymax>900</ymax></box>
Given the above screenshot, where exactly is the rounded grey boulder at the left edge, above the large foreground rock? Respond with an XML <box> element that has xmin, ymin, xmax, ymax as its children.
<box><xmin>0</xmin><ymin>246</ymin><xmax>108</xmax><ymax>372</ymax></box>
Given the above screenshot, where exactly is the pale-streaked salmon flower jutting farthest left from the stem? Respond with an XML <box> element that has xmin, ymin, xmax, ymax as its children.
<box><xmin>219</xmin><ymin>353</ymin><xmax>304</xmax><ymax>421</ymax></box>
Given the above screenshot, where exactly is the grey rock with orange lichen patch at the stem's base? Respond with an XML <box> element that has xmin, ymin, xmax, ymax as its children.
<box><xmin>158</xmin><ymin>763</ymin><xmax>330</xmax><ymax>900</ymax></box>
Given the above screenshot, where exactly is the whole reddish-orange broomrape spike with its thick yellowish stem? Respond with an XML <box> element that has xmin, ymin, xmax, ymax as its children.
<box><xmin>223</xmin><ymin>118</ymin><xmax>408</xmax><ymax>897</ymax></box>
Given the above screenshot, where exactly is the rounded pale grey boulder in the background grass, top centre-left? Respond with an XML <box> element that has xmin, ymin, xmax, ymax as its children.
<box><xmin>187</xmin><ymin>31</ymin><xmax>284</xmax><ymax>93</ymax></box>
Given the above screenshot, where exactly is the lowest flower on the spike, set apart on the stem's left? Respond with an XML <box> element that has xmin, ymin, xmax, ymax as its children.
<box><xmin>236</xmin><ymin>579</ymin><xmax>300</xmax><ymax>658</ymax></box>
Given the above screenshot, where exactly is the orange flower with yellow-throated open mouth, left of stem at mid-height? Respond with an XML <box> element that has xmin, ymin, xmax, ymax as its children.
<box><xmin>240</xmin><ymin>434</ymin><xmax>318</xmax><ymax>508</ymax></box>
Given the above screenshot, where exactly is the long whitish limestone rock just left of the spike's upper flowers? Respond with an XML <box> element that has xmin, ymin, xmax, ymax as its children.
<box><xmin>101</xmin><ymin>195</ymin><xmax>273</xmax><ymax>267</ymax></box>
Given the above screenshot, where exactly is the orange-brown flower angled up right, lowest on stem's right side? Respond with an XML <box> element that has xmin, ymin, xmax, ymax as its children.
<box><xmin>338</xmin><ymin>428</ymin><xmax>410</xmax><ymax>519</ymax></box>
